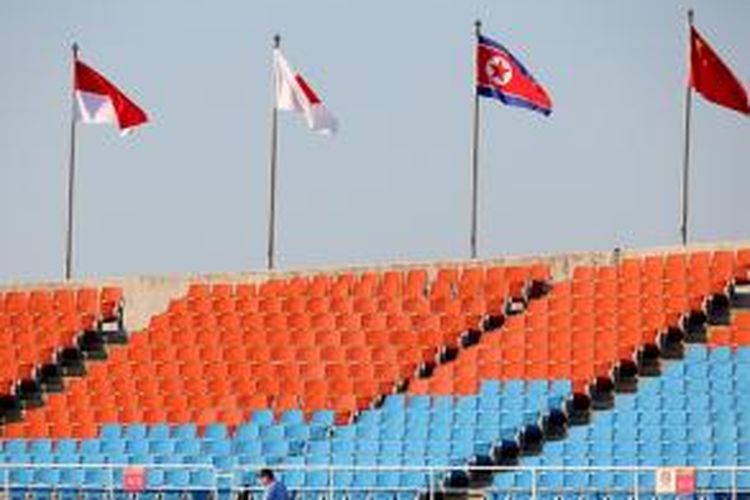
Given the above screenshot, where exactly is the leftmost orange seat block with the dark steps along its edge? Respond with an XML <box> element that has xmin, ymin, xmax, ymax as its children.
<box><xmin>0</xmin><ymin>287</ymin><xmax>126</xmax><ymax>428</ymax></box>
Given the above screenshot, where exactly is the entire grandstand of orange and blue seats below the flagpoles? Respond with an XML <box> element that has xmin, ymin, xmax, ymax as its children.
<box><xmin>0</xmin><ymin>243</ymin><xmax>750</xmax><ymax>499</ymax></box>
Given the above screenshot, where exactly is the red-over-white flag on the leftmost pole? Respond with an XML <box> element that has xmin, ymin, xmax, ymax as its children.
<box><xmin>73</xmin><ymin>59</ymin><xmax>148</xmax><ymax>134</ymax></box>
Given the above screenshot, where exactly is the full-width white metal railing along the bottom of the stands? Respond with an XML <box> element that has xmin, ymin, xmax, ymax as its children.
<box><xmin>0</xmin><ymin>463</ymin><xmax>750</xmax><ymax>500</ymax></box>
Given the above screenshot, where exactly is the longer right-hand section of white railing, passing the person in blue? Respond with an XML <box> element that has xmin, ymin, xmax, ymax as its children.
<box><xmin>233</xmin><ymin>465</ymin><xmax>750</xmax><ymax>500</ymax></box>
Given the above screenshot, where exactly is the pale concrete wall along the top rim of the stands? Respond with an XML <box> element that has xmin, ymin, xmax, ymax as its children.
<box><xmin>0</xmin><ymin>240</ymin><xmax>750</xmax><ymax>331</ymax></box>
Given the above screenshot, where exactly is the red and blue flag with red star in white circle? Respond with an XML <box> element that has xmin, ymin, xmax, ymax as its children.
<box><xmin>476</xmin><ymin>35</ymin><xmax>552</xmax><ymax>115</ymax></box>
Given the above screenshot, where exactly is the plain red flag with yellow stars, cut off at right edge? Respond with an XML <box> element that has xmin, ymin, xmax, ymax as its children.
<box><xmin>690</xmin><ymin>26</ymin><xmax>750</xmax><ymax>115</ymax></box>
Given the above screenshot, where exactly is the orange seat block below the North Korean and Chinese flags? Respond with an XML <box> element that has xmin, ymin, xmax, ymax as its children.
<box><xmin>410</xmin><ymin>252</ymin><xmax>734</xmax><ymax>394</ymax></box>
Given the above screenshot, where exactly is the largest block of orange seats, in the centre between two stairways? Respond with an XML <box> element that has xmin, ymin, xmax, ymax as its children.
<box><xmin>6</xmin><ymin>266</ymin><xmax>548</xmax><ymax>437</ymax></box>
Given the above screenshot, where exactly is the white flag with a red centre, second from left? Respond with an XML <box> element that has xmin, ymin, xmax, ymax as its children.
<box><xmin>273</xmin><ymin>49</ymin><xmax>338</xmax><ymax>135</ymax></box>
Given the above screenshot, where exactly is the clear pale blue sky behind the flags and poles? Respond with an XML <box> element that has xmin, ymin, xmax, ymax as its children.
<box><xmin>0</xmin><ymin>0</ymin><xmax>750</xmax><ymax>282</ymax></box>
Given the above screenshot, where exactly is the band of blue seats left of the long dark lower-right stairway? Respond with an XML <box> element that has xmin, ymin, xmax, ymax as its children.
<box><xmin>3</xmin><ymin>382</ymin><xmax>570</xmax><ymax>488</ymax></box>
